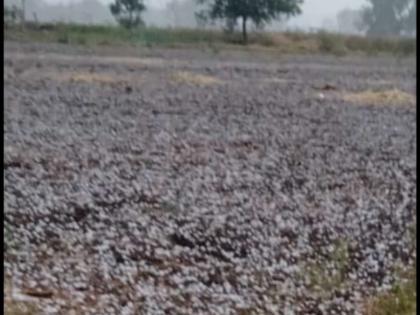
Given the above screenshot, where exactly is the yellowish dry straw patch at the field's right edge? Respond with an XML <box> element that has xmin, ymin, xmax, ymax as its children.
<box><xmin>343</xmin><ymin>89</ymin><xmax>416</xmax><ymax>105</ymax></box>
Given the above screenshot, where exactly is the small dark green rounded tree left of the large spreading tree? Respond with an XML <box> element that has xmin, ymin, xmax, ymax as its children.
<box><xmin>109</xmin><ymin>0</ymin><xmax>146</xmax><ymax>29</ymax></box>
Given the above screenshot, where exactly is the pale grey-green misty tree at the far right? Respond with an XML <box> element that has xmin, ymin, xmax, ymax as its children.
<box><xmin>362</xmin><ymin>0</ymin><xmax>416</xmax><ymax>36</ymax></box>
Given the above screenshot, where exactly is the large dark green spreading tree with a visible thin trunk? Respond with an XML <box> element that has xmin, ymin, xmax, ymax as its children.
<box><xmin>197</xmin><ymin>0</ymin><xmax>303</xmax><ymax>43</ymax></box>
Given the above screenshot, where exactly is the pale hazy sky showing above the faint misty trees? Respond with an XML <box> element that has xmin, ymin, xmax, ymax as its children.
<box><xmin>40</xmin><ymin>0</ymin><xmax>366</xmax><ymax>27</ymax></box>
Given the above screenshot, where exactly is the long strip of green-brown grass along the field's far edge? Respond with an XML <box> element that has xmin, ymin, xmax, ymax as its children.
<box><xmin>4</xmin><ymin>23</ymin><xmax>416</xmax><ymax>56</ymax></box>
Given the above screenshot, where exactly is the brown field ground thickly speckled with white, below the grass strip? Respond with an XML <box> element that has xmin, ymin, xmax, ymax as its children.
<box><xmin>4</xmin><ymin>43</ymin><xmax>417</xmax><ymax>314</ymax></box>
